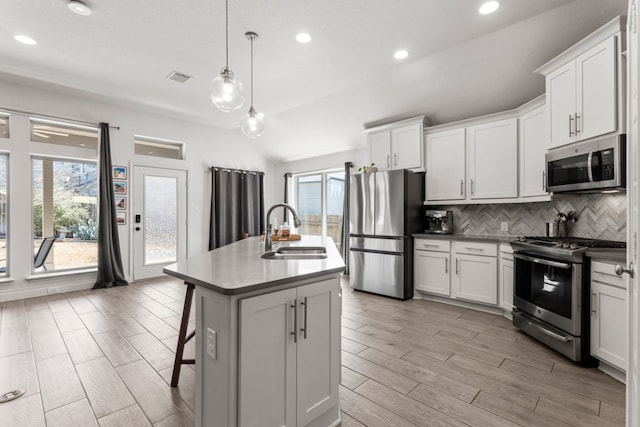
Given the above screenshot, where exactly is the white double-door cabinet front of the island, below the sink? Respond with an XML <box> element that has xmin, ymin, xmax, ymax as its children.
<box><xmin>238</xmin><ymin>279</ymin><xmax>340</xmax><ymax>426</ymax></box>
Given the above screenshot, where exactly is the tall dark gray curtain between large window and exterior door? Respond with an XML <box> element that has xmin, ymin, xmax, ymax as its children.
<box><xmin>93</xmin><ymin>123</ymin><xmax>128</xmax><ymax>289</ymax></box>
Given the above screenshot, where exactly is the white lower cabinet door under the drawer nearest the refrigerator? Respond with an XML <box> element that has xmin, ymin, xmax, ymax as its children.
<box><xmin>413</xmin><ymin>251</ymin><xmax>451</xmax><ymax>296</ymax></box>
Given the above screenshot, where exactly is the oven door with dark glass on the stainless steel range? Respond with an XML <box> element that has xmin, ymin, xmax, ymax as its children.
<box><xmin>513</xmin><ymin>252</ymin><xmax>582</xmax><ymax>336</ymax></box>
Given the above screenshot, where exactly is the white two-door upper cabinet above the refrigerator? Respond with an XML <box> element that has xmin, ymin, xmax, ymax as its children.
<box><xmin>366</xmin><ymin>116</ymin><xmax>426</xmax><ymax>170</ymax></box>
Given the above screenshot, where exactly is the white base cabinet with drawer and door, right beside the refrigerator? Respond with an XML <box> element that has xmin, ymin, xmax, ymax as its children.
<box><xmin>413</xmin><ymin>238</ymin><xmax>451</xmax><ymax>296</ymax></box>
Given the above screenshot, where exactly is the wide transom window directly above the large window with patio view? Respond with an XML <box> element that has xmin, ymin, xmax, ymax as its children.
<box><xmin>31</xmin><ymin>119</ymin><xmax>98</xmax><ymax>150</ymax></box>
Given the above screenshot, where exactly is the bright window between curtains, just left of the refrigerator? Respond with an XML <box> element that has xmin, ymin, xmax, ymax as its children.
<box><xmin>293</xmin><ymin>171</ymin><xmax>344</xmax><ymax>249</ymax></box>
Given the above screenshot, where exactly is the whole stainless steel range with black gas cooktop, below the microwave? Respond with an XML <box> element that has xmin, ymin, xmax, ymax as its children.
<box><xmin>511</xmin><ymin>237</ymin><xmax>626</xmax><ymax>365</ymax></box>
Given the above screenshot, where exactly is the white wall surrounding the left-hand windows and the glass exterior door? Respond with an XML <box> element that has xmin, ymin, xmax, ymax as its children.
<box><xmin>0</xmin><ymin>76</ymin><xmax>273</xmax><ymax>301</ymax></box>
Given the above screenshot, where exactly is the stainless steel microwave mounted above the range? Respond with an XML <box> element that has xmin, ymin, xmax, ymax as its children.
<box><xmin>546</xmin><ymin>135</ymin><xmax>626</xmax><ymax>193</ymax></box>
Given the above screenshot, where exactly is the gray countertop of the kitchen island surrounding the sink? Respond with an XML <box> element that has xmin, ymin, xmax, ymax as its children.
<box><xmin>162</xmin><ymin>235</ymin><xmax>345</xmax><ymax>295</ymax></box>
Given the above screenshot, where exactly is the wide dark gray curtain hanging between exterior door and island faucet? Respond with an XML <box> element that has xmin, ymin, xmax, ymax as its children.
<box><xmin>209</xmin><ymin>167</ymin><xmax>264</xmax><ymax>250</ymax></box>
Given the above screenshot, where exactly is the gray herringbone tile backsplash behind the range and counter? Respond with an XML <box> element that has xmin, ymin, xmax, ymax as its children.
<box><xmin>442</xmin><ymin>194</ymin><xmax>627</xmax><ymax>241</ymax></box>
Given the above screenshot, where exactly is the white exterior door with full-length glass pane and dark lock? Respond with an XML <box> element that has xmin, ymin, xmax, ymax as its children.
<box><xmin>131</xmin><ymin>166</ymin><xmax>187</xmax><ymax>280</ymax></box>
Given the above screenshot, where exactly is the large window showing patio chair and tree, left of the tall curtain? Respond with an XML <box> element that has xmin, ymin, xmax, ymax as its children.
<box><xmin>32</xmin><ymin>158</ymin><xmax>98</xmax><ymax>271</ymax></box>
